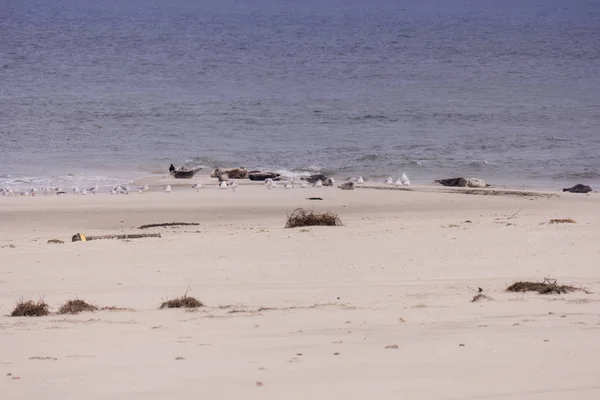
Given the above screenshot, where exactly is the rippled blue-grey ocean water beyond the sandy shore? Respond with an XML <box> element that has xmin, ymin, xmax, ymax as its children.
<box><xmin>0</xmin><ymin>0</ymin><xmax>600</xmax><ymax>189</ymax></box>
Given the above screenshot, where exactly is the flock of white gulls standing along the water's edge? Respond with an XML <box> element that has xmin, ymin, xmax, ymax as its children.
<box><xmin>0</xmin><ymin>172</ymin><xmax>410</xmax><ymax>197</ymax></box>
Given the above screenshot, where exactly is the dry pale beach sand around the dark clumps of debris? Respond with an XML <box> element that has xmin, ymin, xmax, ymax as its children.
<box><xmin>0</xmin><ymin>182</ymin><xmax>600</xmax><ymax>399</ymax></box>
